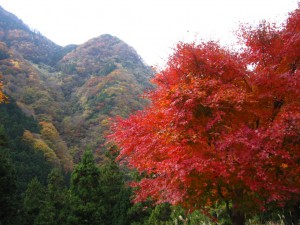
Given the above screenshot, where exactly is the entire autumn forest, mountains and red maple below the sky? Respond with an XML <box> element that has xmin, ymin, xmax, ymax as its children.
<box><xmin>0</xmin><ymin>3</ymin><xmax>300</xmax><ymax>225</ymax></box>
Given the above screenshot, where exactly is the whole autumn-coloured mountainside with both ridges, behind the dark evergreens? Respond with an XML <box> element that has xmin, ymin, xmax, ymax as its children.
<box><xmin>0</xmin><ymin>7</ymin><xmax>153</xmax><ymax>167</ymax></box>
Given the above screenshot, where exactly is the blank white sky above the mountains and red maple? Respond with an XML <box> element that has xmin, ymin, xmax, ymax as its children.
<box><xmin>0</xmin><ymin>0</ymin><xmax>298</xmax><ymax>65</ymax></box>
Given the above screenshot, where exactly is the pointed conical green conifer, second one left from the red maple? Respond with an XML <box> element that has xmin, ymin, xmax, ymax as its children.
<box><xmin>68</xmin><ymin>150</ymin><xmax>104</xmax><ymax>225</ymax></box>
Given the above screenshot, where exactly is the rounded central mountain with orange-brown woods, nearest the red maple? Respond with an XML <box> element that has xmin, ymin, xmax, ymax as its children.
<box><xmin>57</xmin><ymin>34</ymin><xmax>152</xmax><ymax>161</ymax></box>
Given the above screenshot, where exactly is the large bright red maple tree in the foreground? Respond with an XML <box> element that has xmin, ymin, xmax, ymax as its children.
<box><xmin>110</xmin><ymin>8</ymin><xmax>300</xmax><ymax>224</ymax></box>
